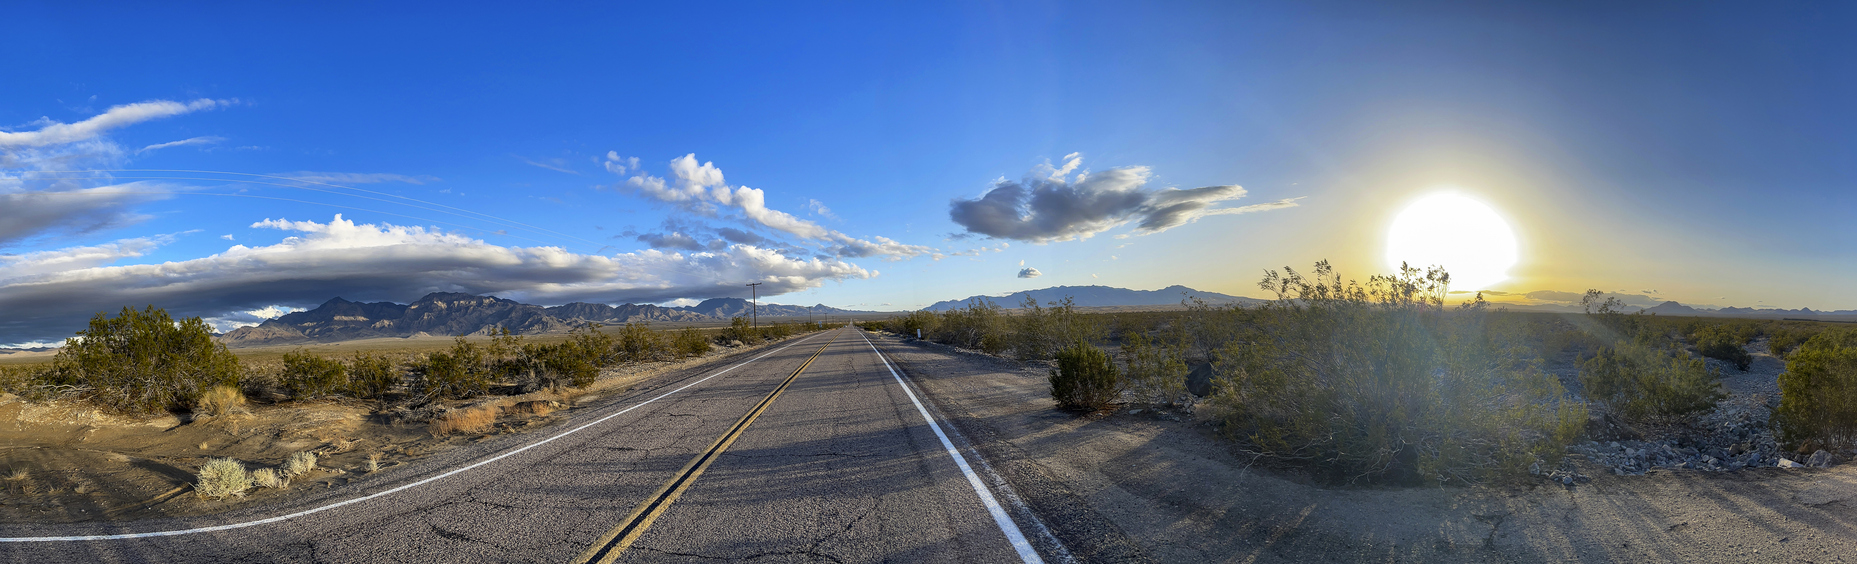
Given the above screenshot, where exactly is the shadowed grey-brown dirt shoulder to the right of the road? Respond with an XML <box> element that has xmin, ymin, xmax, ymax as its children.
<box><xmin>871</xmin><ymin>334</ymin><xmax>1857</xmax><ymax>562</ymax></box>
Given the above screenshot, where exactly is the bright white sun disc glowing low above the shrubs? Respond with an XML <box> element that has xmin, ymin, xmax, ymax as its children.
<box><xmin>1387</xmin><ymin>193</ymin><xmax>1515</xmax><ymax>291</ymax></box>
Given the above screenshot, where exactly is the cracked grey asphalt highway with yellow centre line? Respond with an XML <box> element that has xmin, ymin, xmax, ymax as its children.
<box><xmin>0</xmin><ymin>328</ymin><xmax>1066</xmax><ymax>562</ymax></box>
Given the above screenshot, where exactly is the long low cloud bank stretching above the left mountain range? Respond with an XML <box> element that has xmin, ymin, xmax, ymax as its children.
<box><xmin>0</xmin><ymin>215</ymin><xmax>878</xmax><ymax>341</ymax></box>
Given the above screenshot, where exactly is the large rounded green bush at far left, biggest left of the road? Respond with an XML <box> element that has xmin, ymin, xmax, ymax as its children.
<box><xmin>45</xmin><ymin>306</ymin><xmax>241</xmax><ymax>412</ymax></box>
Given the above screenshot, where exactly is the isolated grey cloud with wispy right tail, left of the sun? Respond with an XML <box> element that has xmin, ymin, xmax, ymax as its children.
<box><xmin>949</xmin><ymin>152</ymin><xmax>1298</xmax><ymax>243</ymax></box>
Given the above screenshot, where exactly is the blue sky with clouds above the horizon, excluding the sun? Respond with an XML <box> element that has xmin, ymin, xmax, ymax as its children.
<box><xmin>0</xmin><ymin>2</ymin><xmax>1857</xmax><ymax>343</ymax></box>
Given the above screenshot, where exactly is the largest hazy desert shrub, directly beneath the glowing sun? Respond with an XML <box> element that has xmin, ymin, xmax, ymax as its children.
<box><xmin>1207</xmin><ymin>262</ymin><xmax>1586</xmax><ymax>482</ymax></box>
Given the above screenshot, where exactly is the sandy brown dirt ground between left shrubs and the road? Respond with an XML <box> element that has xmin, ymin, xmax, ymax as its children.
<box><xmin>0</xmin><ymin>340</ymin><xmax>791</xmax><ymax>523</ymax></box>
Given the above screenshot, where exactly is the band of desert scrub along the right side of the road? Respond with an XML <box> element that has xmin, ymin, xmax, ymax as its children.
<box><xmin>878</xmin><ymin>262</ymin><xmax>1857</xmax><ymax>484</ymax></box>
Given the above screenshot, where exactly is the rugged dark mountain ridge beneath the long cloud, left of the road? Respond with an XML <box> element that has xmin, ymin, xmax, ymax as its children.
<box><xmin>219</xmin><ymin>291</ymin><xmax>869</xmax><ymax>347</ymax></box>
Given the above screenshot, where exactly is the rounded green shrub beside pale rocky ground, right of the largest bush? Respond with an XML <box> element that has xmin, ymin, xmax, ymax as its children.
<box><xmin>1580</xmin><ymin>343</ymin><xmax>1725</xmax><ymax>421</ymax></box>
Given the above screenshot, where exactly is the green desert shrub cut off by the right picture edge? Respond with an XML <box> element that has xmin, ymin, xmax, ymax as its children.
<box><xmin>1773</xmin><ymin>330</ymin><xmax>1857</xmax><ymax>449</ymax></box>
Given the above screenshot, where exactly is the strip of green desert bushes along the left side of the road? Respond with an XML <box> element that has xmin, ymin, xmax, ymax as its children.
<box><xmin>0</xmin><ymin>306</ymin><xmax>836</xmax><ymax>424</ymax></box>
